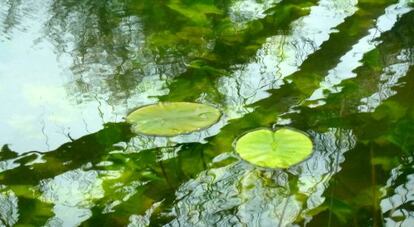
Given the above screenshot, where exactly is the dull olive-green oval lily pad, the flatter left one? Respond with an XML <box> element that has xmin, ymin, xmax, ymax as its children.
<box><xmin>127</xmin><ymin>102</ymin><xmax>221</xmax><ymax>136</ymax></box>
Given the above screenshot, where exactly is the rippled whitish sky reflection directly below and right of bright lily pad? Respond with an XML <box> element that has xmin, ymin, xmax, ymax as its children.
<box><xmin>170</xmin><ymin>128</ymin><xmax>355</xmax><ymax>226</ymax></box>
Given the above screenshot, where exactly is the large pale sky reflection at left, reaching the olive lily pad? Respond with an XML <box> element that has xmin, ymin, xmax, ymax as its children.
<box><xmin>0</xmin><ymin>1</ymin><xmax>170</xmax><ymax>152</ymax></box>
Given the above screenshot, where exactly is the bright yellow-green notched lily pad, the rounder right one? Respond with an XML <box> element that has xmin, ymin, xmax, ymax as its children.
<box><xmin>236</xmin><ymin>128</ymin><xmax>313</xmax><ymax>168</ymax></box>
